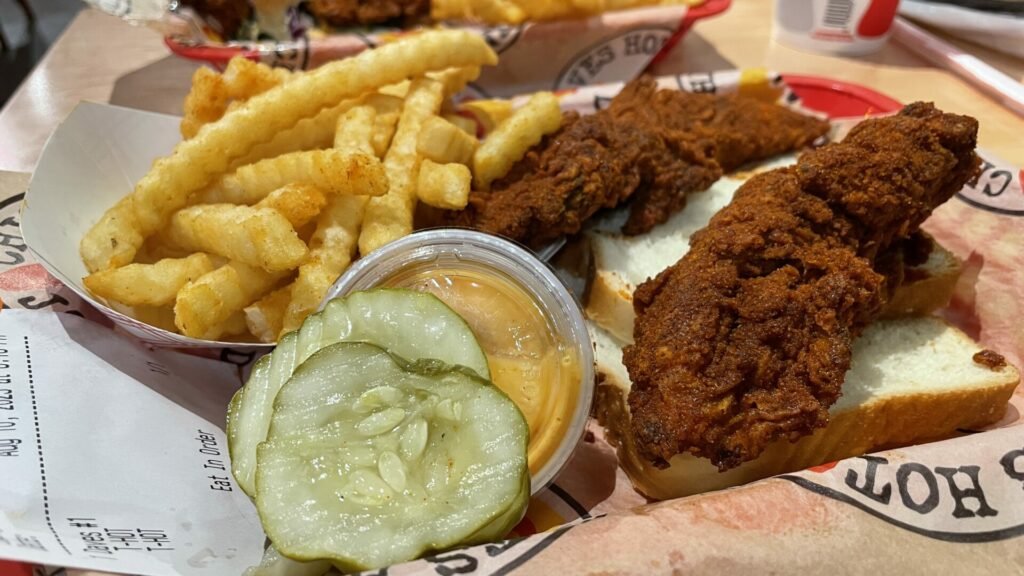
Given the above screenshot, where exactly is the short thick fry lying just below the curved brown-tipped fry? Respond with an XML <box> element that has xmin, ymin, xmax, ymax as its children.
<box><xmin>166</xmin><ymin>204</ymin><xmax>307</xmax><ymax>270</ymax></box>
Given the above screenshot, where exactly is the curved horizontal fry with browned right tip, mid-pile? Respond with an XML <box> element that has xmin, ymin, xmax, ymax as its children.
<box><xmin>200</xmin><ymin>150</ymin><xmax>387</xmax><ymax>204</ymax></box>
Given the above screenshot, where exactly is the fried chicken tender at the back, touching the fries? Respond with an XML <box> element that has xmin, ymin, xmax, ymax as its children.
<box><xmin>449</xmin><ymin>77</ymin><xmax>828</xmax><ymax>247</ymax></box>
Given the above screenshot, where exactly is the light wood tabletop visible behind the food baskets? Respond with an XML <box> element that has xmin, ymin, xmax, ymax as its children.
<box><xmin>0</xmin><ymin>0</ymin><xmax>1024</xmax><ymax>172</ymax></box>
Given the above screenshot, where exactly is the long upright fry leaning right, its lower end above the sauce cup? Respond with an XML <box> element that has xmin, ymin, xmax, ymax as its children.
<box><xmin>359</xmin><ymin>78</ymin><xmax>443</xmax><ymax>255</ymax></box>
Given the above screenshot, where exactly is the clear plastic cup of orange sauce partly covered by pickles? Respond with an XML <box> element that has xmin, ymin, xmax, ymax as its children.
<box><xmin>325</xmin><ymin>229</ymin><xmax>594</xmax><ymax>494</ymax></box>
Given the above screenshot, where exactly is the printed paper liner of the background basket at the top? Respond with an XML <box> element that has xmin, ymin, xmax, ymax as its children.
<box><xmin>87</xmin><ymin>0</ymin><xmax>731</xmax><ymax>96</ymax></box>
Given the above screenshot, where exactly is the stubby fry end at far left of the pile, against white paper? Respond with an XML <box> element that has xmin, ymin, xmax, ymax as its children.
<box><xmin>78</xmin><ymin>195</ymin><xmax>145</xmax><ymax>273</ymax></box>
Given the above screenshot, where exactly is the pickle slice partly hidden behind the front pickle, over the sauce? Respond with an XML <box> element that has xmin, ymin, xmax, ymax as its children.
<box><xmin>227</xmin><ymin>289</ymin><xmax>490</xmax><ymax>496</ymax></box>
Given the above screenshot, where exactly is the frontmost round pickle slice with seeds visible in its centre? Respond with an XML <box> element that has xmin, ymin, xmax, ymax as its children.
<box><xmin>256</xmin><ymin>343</ymin><xmax>529</xmax><ymax>570</ymax></box>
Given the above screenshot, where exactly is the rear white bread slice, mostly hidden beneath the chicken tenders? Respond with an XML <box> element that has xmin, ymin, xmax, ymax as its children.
<box><xmin>586</xmin><ymin>168</ymin><xmax>961</xmax><ymax>342</ymax></box>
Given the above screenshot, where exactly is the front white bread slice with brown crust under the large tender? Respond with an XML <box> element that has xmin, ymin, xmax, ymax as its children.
<box><xmin>590</xmin><ymin>317</ymin><xmax>1020</xmax><ymax>500</ymax></box>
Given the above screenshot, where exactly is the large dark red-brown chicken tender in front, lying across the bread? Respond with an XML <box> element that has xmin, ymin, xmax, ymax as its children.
<box><xmin>624</xmin><ymin>102</ymin><xmax>979</xmax><ymax>470</ymax></box>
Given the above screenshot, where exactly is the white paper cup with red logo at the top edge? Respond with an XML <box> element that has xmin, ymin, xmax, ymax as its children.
<box><xmin>773</xmin><ymin>0</ymin><xmax>899</xmax><ymax>56</ymax></box>
